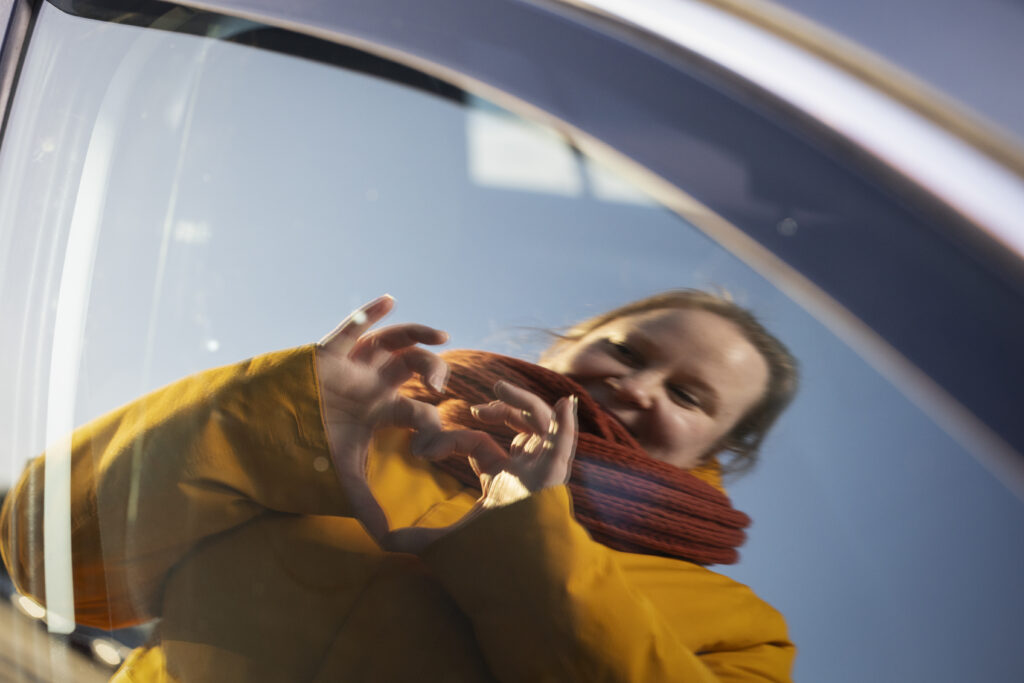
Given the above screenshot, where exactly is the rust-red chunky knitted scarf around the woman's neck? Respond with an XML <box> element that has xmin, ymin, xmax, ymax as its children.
<box><xmin>402</xmin><ymin>350</ymin><xmax>751</xmax><ymax>564</ymax></box>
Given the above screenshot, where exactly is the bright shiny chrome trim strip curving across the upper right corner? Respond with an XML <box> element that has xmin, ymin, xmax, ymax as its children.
<box><xmin>559</xmin><ymin>0</ymin><xmax>1024</xmax><ymax>264</ymax></box>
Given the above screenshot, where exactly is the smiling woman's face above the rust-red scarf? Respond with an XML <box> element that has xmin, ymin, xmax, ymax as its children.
<box><xmin>543</xmin><ymin>308</ymin><xmax>768</xmax><ymax>469</ymax></box>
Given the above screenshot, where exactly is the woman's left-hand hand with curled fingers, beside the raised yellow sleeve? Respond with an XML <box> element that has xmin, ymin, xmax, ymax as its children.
<box><xmin>315</xmin><ymin>295</ymin><xmax>505</xmax><ymax>547</ymax></box>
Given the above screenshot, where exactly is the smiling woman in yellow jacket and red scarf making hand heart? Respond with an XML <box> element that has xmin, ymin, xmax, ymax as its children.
<box><xmin>2</xmin><ymin>292</ymin><xmax>795</xmax><ymax>681</ymax></box>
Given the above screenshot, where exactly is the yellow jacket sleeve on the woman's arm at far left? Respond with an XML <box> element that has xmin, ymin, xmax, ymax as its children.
<box><xmin>0</xmin><ymin>346</ymin><xmax>347</xmax><ymax>628</ymax></box>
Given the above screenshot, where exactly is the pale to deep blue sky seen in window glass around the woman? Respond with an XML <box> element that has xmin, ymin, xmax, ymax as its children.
<box><xmin>0</xmin><ymin>6</ymin><xmax>1024</xmax><ymax>681</ymax></box>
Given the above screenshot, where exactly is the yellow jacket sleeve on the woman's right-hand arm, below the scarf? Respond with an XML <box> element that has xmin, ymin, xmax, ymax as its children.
<box><xmin>424</xmin><ymin>486</ymin><xmax>795</xmax><ymax>682</ymax></box>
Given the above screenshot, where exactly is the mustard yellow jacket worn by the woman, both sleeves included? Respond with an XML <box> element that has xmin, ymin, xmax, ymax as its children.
<box><xmin>0</xmin><ymin>347</ymin><xmax>795</xmax><ymax>682</ymax></box>
